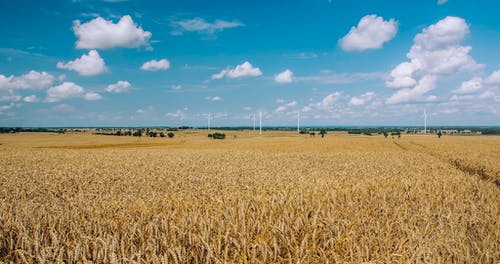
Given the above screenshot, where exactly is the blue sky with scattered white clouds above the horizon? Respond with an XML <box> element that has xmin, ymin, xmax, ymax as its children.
<box><xmin>0</xmin><ymin>0</ymin><xmax>500</xmax><ymax>126</ymax></box>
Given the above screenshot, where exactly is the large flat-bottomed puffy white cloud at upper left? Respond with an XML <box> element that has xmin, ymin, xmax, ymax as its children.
<box><xmin>73</xmin><ymin>15</ymin><xmax>151</xmax><ymax>49</ymax></box>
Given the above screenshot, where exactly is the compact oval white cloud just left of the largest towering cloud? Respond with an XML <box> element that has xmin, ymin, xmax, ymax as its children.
<box><xmin>339</xmin><ymin>15</ymin><xmax>398</xmax><ymax>51</ymax></box>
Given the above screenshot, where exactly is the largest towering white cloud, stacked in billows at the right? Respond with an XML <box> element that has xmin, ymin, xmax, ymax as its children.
<box><xmin>386</xmin><ymin>16</ymin><xmax>482</xmax><ymax>104</ymax></box>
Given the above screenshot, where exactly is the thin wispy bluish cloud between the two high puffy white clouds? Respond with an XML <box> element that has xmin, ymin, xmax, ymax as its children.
<box><xmin>171</xmin><ymin>17</ymin><xmax>244</xmax><ymax>36</ymax></box>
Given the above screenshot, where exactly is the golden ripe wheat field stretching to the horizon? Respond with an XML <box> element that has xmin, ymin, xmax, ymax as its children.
<box><xmin>0</xmin><ymin>131</ymin><xmax>500</xmax><ymax>263</ymax></box>
